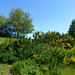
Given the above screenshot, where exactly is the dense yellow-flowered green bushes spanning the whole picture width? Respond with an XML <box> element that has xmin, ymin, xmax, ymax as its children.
<box><xmin>0</xmin><ymin>31</ymin><xmax>75</xmax><ymax>75</ymax></box>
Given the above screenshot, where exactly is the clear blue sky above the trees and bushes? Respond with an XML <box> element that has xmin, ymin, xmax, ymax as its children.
<box><xmin>0</xmin><ymin>0</ymin><xmax>75</xmax><ymax>37</ymax></box>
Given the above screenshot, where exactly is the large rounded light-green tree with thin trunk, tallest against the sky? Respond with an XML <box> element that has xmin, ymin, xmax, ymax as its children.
<box><xmin>7</xmin><ymin>8</ymin><xmax>34</xmax><ymax>37</ymax></box>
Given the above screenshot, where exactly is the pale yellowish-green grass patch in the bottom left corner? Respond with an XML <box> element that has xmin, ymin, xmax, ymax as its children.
<box><xmin>0</xmin><ymin>64</ymin><xmax>11</xmax><ymax>75</ymax></box>
